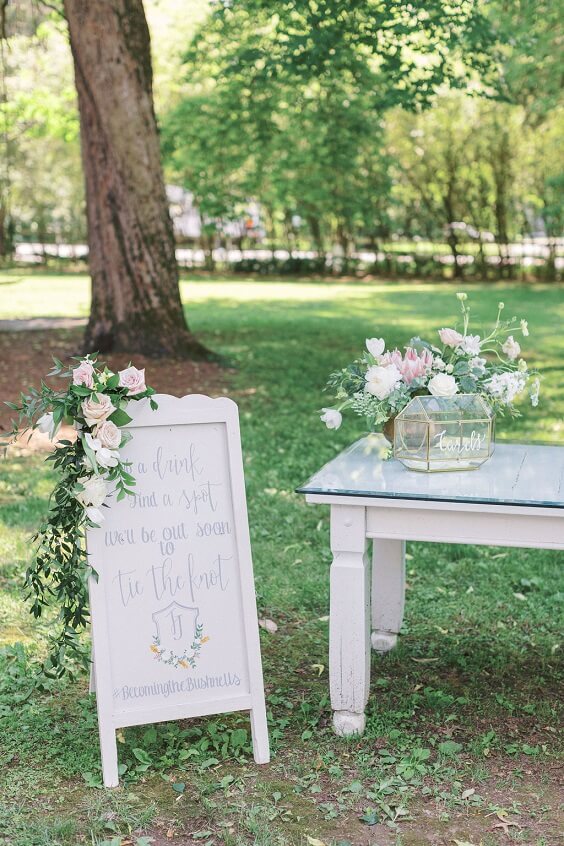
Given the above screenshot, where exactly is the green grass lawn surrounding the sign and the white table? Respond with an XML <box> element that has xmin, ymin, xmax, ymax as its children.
<box><xmin>0</xmin><ymin>272</ymin><xmax>564</xmax><ymax>846</ymax></box>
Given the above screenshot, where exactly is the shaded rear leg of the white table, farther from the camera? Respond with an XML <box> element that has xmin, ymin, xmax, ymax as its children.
<box><xmin>371</xmin><ymin>538</ymin><xmax>405</xmax><ymax>652</ymax></box>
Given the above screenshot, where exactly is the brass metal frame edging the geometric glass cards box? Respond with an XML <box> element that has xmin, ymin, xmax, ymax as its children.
<box><xmin>394</xmin><ymin>394</ymin><xmax>495</xmax><ymax>473</ymax></box>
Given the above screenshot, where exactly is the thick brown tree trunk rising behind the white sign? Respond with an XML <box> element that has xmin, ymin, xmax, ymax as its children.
<box><xmin>64</xmin><ymin>0</ymin><xmax>207</xmax><ymax>358</ymax></box>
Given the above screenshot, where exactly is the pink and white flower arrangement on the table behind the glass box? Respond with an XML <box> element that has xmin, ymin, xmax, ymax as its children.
<box><xmin>321</xmin><ymin>293</ymin><xmax>540</xmax><ymax>438</ymax></box>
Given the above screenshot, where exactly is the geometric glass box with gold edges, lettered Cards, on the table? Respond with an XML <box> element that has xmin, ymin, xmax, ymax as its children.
<box><xmin>394</xmin><ymin>394</ymin><xmax>495</xmax><ymax>473</ymax></box>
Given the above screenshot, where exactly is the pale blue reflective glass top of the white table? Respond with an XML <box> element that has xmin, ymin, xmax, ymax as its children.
<box><xmin>297</xmin><ymin>434</ymin><xmax>564</xmax><ymax>509</ymax></box>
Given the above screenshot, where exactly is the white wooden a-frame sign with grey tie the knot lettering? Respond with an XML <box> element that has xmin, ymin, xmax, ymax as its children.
<box><xmin>87</xmin><ymin>395</ymin><xmax>269</xmax><ymax>787</ymax></box>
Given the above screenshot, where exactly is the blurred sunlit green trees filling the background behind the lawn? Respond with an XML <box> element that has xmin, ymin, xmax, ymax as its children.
<box><xmin>0</xmin><ymin>0</ymin><xmax>564</xmax><ymax>277</ymax></box>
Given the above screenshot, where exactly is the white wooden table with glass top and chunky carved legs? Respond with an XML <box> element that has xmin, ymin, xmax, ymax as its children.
<box><xmin>298</xmin><ymin>435</ymin><xmax>564</xmax><ymax>735</ymax></box>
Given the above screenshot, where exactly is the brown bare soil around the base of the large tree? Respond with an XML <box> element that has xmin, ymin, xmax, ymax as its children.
<box><xmin>0</xmin><ymin>321</ymin><xmax>231</xmax><ymax>453</ymax></box>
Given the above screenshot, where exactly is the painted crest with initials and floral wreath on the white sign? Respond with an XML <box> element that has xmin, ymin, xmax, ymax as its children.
<box><xmin>150</xmin><ymin>601</ymin><xmax>209</xmax><ymax>670</ymax></box>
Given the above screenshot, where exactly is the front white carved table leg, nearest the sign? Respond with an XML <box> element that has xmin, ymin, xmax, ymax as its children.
<box><xmin>329</xmin><ymin>505</ymin><xmax>370</xmax><ymax>736</ymax></box>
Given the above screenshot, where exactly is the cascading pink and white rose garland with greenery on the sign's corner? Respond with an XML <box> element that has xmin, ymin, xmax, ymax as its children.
<box><xmin>7</xmin><ymin>355</ymin><xmax>157</xmax><ymax>676</ymax></box>
